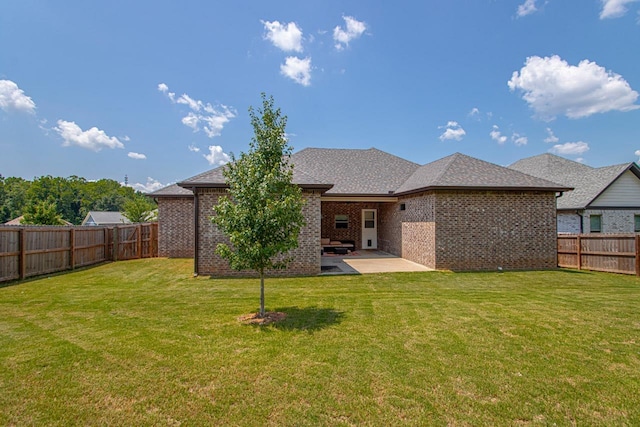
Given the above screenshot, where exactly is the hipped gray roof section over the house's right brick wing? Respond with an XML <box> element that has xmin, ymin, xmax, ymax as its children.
<box><xmin>397</xmin><ymin>153</ymin><xmax>566</xmax><ymax>193</ymax></box>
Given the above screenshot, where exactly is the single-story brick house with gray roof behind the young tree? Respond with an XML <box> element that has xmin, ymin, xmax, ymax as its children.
<box><xmin>149</xmin><ymin>148</ymin><xmax>570</xmax><ymax>276</ymax></box>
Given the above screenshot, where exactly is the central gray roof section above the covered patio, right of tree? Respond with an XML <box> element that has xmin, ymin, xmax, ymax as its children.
<box><xmin>291</xmin><ymin>148</ymin><xmax>420</xmax><ymax>195</ymax></box>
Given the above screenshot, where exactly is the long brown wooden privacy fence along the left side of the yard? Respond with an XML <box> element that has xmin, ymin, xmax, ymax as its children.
<box><xmin>0</xmin><ymin>223</ymin><xmax>158</xmax><ymax>282</ymax></box>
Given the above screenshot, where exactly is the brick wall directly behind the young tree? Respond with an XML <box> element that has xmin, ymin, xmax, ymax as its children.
<box><xmin>198</xmin><ymin>189</ymin><xmax>321</xmax><ymax>277</ymax></box>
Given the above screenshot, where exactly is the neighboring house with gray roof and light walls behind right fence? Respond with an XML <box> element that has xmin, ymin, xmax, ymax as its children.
<box><xmin>509</xmin><ymin>154</ymin><xmax>640</xmax><ymax>233</ymax></box>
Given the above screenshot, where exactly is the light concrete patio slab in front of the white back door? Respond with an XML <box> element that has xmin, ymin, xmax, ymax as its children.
<box><xmin>321</xmin><ymin>249</ymin><xmax>433</xmax><ymax>275</ymax></box>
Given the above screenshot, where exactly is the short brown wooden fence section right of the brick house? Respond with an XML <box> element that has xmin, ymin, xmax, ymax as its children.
<box><xmin>558</xmin><ymin>234</ymin><xmax>640</xmax><ymax>276</ymax></box>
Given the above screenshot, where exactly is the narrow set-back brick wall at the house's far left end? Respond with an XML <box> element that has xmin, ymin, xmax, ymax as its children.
<box><xmin>158</xmin><ymin>197</ymin><xmax>194</xmax><ymax>258</ymax></box>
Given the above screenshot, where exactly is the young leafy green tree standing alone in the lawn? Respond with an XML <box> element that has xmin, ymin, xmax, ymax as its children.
<box><xmin>211</xmin><ymin>93</ymin><xmax>305</xmax><ymax>317</ymax></box>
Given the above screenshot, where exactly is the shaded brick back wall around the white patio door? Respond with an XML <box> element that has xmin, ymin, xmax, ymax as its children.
<box><xmin>322</xmin><ymin>202</ymin><xmax>382</xmax><ymax>249</ymax></box>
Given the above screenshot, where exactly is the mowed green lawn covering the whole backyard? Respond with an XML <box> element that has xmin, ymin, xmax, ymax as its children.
<box><xmin>0</xmin><ymin>259</ymin><xmax>640</xmax><ymax>426</ymax></box>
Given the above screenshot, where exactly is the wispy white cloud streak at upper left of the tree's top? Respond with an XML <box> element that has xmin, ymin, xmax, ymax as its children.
<box><xmin>158</xmin><ymin>83</ymin><xmax>236</xmax><ymax>138</ymax></box>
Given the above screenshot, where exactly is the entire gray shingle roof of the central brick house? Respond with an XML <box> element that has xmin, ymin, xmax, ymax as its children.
<box><xmin>172</xmin><ymin>148</ymin><xmax>569</xmax><ymax>196</ymax></box>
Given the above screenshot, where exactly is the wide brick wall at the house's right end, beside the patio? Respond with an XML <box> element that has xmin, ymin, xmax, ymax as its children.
<box><xmin>435</xmin><ymin>191</ymin><xmax>557</xmax><ymax>270</ymax></box>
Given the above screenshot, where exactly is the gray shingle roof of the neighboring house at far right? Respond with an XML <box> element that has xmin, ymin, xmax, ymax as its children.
<box><xmin>509</xmin><ymin>153</ymin><xmax>637</xmax><ymax>209</ymax></box>
